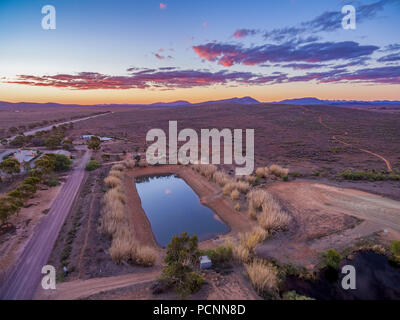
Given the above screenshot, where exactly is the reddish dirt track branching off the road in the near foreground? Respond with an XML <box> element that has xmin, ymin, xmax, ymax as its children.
<box><xmin>34</xmin><ymin>269</ymin><xmax>161</xmax><ymax>300</ymax></box>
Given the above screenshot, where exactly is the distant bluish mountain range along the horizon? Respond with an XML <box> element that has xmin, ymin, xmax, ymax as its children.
<box><xmin>0</xmin><ymin>97</ymin><xmax>400</xmax><ymax>108</ymax></box>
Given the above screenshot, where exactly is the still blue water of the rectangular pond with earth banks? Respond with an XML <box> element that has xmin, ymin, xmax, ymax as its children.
<box><xmin>135</xmin><ymin>175</ymin><xmax>229</xmax><ymax>247</ymax></box>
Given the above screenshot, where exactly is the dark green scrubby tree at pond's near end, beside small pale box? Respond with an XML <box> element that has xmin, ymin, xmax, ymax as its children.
<box><xmin>161</xmin><ymin>232</ymin><xmax>203</xmax><ymax>298</ymax></box>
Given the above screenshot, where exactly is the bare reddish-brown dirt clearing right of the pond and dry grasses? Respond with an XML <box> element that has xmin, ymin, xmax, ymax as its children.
<box><xmin>257</xmin><ymin>181</ymin><xmax>400</xmax><ymax>268</ymax></box>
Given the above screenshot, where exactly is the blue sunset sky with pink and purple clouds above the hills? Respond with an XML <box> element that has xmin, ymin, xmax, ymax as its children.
<box><xmin>0</xmin><ymin>0</ymin><xmax>400</xmax><ymax>104</ymax></box>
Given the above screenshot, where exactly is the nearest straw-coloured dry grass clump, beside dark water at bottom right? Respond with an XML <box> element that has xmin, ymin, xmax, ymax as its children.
<box><xmin>245</xmin><ymin>259</ymin><xmax>278</xmax><ymax>295</ymax></box>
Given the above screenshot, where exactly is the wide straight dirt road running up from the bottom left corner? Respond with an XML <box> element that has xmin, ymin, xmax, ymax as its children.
<box><xmin>0</xmin><ymin>151</ymin><xmax>90</xmax><ymax>300</ymax></box>
